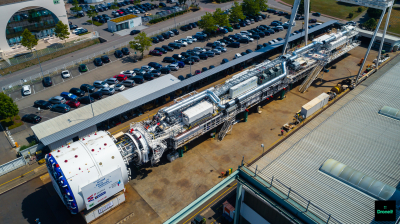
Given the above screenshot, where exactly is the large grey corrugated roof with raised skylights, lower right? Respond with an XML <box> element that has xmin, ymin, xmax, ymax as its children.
<box><xmin>251</xmin><ymin>62</ymin><xmax>400</xmax><ymax>223</ymax></box>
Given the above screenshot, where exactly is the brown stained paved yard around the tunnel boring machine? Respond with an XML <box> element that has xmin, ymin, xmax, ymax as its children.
<box><xmin>0</xmin><ymin>43</ymin><xmax>390</xmax><ymax>223</ymax></box>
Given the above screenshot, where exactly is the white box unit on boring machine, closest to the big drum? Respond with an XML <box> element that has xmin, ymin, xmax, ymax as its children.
<box><xmin>182</xmin><ymin>101</ymin><xmax>214</xmax><ymax>125</ymax></box>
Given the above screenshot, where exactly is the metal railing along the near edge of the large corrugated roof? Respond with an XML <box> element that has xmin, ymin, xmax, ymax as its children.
<box><xmin>243</xmin><ymin>161</ymin><xmax>341</xmax><ymax>224</ymax></box>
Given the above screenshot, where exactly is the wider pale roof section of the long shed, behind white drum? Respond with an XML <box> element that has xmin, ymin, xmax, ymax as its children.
<box><xmin>32</xmin><ymin>74</ymin><xmax>180</xmax><ymax>145</ymax></box>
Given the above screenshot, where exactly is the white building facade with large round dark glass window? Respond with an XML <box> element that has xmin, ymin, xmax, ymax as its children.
<box><xmin>0</xmin><ymin>0</ymin><xmax>68</xmax><ymax>51</ymax></box>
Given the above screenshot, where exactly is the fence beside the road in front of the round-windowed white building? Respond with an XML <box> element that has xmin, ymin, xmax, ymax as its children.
<box><xmin>0</xmin><ymin>34</ymin><xmax>98</xmax><ymax>72</ymax></box>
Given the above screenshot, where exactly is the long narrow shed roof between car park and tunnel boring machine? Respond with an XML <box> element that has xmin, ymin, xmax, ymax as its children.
<box><xmin>32</xmin><ymin>20</ymin><xmax>337</xmax><ymax>145</ymax></box>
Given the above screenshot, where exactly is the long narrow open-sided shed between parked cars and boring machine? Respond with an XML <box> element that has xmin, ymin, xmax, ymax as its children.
<box><xmin>32</xmin><ymin>20</ymin><xmax>337</xmax><ymax>150</ymax></box>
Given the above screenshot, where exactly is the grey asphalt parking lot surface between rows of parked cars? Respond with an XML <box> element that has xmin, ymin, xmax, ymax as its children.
<box><xmin>12</xmin><ymin>11</ymin><xmax>316</xmax><ymax>127</ymax></box>
